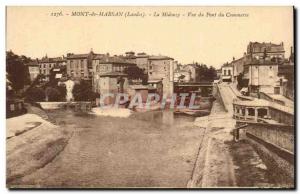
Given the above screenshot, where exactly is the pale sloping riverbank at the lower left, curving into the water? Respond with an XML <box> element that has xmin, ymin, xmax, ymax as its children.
<box><xmin>6</xmin><ymin>111</ymin><xmax>71</xmax><ymax>188</ymax></box>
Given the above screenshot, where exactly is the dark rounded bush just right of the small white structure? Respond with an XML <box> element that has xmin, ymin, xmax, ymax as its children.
<box><xmin>72</xmin><ymin>80</ymin><xmax>98</xmax><ymax>101</ymax></box>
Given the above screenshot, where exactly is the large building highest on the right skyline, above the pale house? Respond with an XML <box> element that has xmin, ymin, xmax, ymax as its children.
<box><xmin>247</xmin><ymin>42</ymin><xmax>285</xmax><ymax>61</ymax></box>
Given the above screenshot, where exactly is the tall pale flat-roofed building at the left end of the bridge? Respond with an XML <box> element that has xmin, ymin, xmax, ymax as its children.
<box><xmin>148</xmin><ymin>56</ymin><xmax>174</xmax><ymax>96</ymax></box>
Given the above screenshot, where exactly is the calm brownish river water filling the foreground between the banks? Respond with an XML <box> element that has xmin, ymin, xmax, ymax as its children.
<box><xmin>18</xmin><ymin>110</ymin><xmax>204</xmax><ymax>188</ymax></box>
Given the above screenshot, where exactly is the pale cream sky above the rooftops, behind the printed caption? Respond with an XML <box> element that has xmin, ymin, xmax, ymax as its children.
<box><xmin>6</xmin><ymin>6</ymin><xmax>294</xmax><ymax>68</ymax></box>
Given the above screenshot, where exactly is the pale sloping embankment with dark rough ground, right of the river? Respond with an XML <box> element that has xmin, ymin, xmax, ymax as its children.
<box><xmin>187</xmin><ymin>97</ymin><xmax>293</xmax><ymax>188</ymax></box>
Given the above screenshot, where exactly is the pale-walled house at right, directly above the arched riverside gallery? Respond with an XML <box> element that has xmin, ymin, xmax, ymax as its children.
<box><xmin>244</xmin><ymin>59</ymin><xmax>282</xmax><ymax>95</ymax></box>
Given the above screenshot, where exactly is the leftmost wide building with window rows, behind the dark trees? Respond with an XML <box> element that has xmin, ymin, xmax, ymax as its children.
<box><xmin>39</xmin><ymin>55</ymin><xmax>67</xmax><ymax>81</ymax></box>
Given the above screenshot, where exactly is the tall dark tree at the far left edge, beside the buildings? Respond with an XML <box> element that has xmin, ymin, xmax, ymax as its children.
<box><xmin>6</xmin><ymin>51</ymin><xmax>31</xmax><ymax>91</ymax></box>
